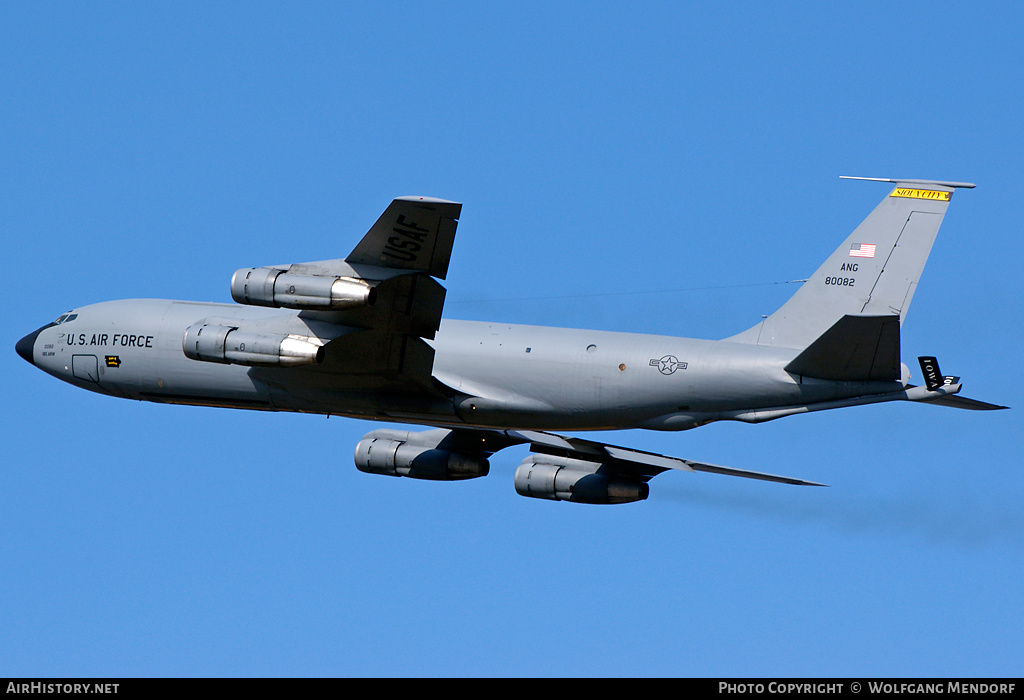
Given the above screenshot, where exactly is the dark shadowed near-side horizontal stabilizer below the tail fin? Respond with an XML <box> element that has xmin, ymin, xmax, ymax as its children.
<box><xmin>785</xmin><ymin>314</ymin><xmax>900</xmax><ymax>382</ymax></box>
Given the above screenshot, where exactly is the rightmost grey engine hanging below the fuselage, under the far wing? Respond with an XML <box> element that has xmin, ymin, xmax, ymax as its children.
<box><xmin>515</xmin><ymin>454</ymin><xmax>650</xmax><ymax>504</ymax></box>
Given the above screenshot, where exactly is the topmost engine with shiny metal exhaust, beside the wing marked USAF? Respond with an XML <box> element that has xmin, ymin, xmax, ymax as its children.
<box><xmin>231</xmin><ymin>267</ymin><xmax>377</xmax><ymax>310</ymax></box>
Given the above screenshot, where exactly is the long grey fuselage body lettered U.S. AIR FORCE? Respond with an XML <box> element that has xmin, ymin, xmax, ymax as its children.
<box><xmin>19</xmin><ymin>299</ymin><xmax>904</xmax><ymax>430</ymax></box>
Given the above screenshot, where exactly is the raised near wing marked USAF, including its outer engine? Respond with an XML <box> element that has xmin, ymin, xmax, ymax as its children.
<box><xmin>231</xmin><ymin>196</ymin><xmax>462</xmax><ymax>394</ymax></box>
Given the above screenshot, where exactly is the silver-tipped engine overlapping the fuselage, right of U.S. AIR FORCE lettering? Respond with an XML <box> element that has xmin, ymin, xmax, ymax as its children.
<box><xmin>181</xmin><ymin>323</ymin><xmax>324</xmax><ymax>367</ymax></box>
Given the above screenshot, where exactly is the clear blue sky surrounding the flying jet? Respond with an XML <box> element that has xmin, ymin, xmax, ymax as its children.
<box><xmin>0</xmin><ymin>2</ymin><xmax>1024</xmax><ymax>676</ymax></box>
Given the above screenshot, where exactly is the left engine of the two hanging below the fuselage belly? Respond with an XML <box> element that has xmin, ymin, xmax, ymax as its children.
<box><xmin>355</xmin><ymin>433</ymin><xmax>489</xmax><ymax>481</ymax></box>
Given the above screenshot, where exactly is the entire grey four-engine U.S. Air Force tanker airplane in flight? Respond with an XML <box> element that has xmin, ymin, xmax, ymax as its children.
<box><xmin>15</xmin><ymin>177</ymin><xmax>1006</xmax><ymax>504</ymax></box>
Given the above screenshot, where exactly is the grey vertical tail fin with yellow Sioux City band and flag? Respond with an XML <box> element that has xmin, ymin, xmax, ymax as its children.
<box><xmin>728</xmin><ymin>178</ymin><xmax>974</xmax><ymax>350</ymax></box>
